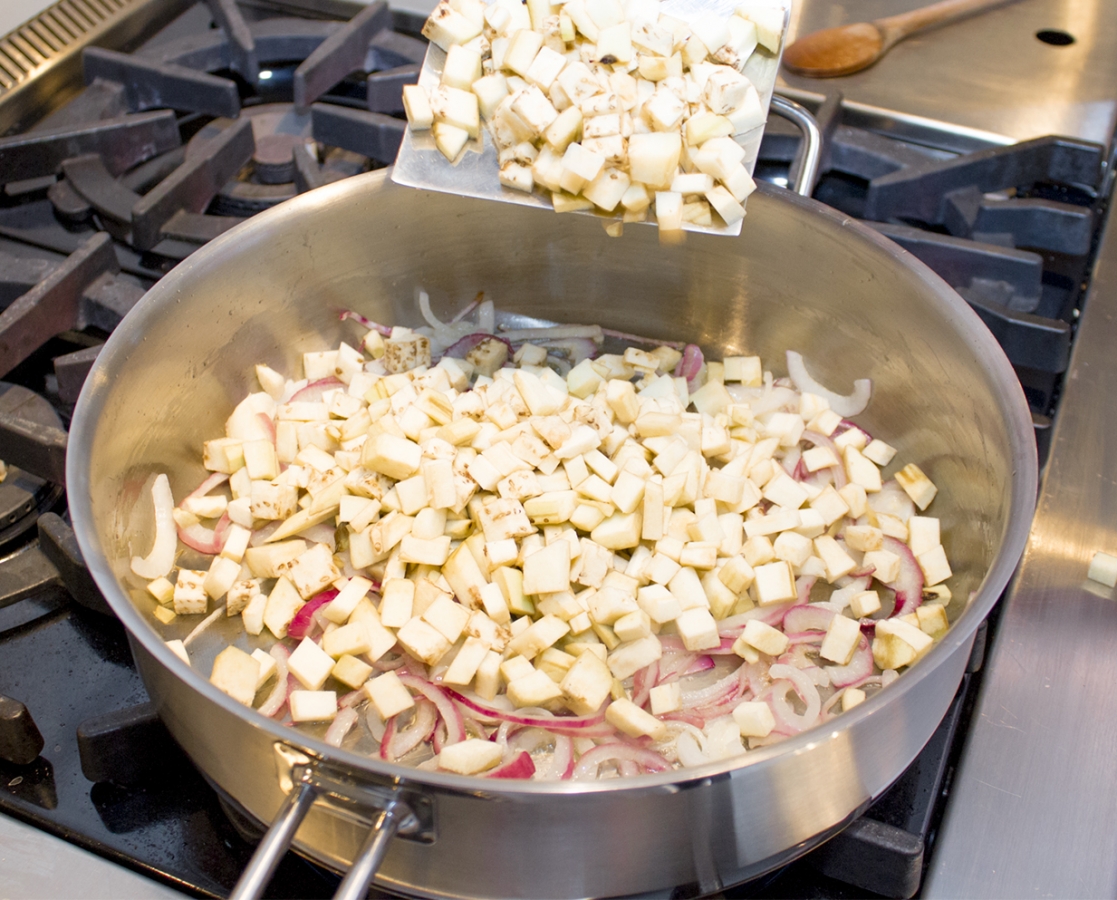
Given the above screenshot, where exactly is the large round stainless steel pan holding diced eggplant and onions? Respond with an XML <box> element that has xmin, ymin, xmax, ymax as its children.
<box><xmin>67</xmin><ymin>172</ymin><xmax>1037</xmax><ymax>898</ymax></box>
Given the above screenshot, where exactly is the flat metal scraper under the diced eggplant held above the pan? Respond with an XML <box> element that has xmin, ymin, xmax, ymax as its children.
<box><xmin>391</xmin><ymin>0</ymin><xmax>791</xmax><ymax>234</ymax></box>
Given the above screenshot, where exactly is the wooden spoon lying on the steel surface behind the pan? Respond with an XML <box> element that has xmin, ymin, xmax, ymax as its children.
<box><xmin>783</xmin><ymin>0</ymin><xmax>1014</xmax><ymax>78</ymax></box>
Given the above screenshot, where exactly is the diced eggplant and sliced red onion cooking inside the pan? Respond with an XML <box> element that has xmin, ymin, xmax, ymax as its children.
<box><xmin>132</xmin><ymin>296</ymin><xmax>951</xmax><ymax>779</ymax></box>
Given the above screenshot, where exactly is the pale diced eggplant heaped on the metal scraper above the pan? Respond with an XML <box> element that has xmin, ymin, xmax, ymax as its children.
<box><xmin>403</xmin><ymin>0</ymin><xmax>784</xmax><ymax>234</ymax></box>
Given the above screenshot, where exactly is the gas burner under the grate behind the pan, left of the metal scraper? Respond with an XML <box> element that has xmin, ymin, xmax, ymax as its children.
<box><xmin>185</xmin><ymin>103</ymin><xmax>373</xmax><ymax>217</ymax></box>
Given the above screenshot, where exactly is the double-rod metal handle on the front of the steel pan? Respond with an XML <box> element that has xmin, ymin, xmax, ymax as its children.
<box><xmin>229</xmin><ymin>745</ymin><xmax>432</xmax><ymax>900</ymax></box>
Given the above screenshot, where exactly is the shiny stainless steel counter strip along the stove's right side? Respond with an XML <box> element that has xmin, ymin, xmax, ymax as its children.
<box><xmin>923</xmin><ymin>202</ymin><xmax>1117</xmax><ymax>898</ymax></box>
